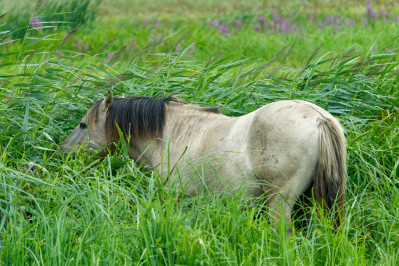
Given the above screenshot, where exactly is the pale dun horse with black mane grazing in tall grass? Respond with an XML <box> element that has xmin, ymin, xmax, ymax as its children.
<box><xmin>61</xmin><ymin>91</ymin><xmax>346</xmax><ymax>234</ymax></box>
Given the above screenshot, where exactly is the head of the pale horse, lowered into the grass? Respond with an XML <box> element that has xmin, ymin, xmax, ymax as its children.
<box><xmin>61</xmin><ymin>91</ymin><xmax>113</xmax><ymax>153</ymax></box>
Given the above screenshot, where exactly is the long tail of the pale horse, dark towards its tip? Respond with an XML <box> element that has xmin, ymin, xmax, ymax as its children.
<box><xmin>313</xmin><ymin>117</ymin><xmax>346</xmax><ymax>227</ymax></box>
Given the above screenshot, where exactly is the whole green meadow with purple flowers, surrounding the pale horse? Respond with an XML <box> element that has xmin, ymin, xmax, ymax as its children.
<box><xmin>0</xmin><ymin>0</ymin><xmax>399</xmax><ymax>265</ymax></box>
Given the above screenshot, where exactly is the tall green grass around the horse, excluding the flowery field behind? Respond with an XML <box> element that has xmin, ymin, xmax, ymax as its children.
<box><xmin>0</xmin><ymin>2</ymin><xmax>399</xmax><ymax>265</ymax></box>
